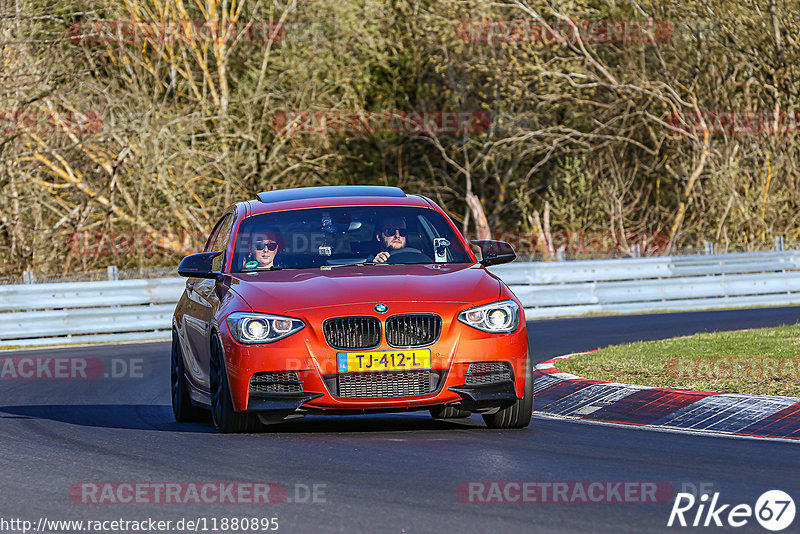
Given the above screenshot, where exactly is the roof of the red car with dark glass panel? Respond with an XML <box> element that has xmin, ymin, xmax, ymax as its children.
<box><xmin>247</xmin><ymin>185</ymin><xmax>432</xmax><ymax>215</ymax></box>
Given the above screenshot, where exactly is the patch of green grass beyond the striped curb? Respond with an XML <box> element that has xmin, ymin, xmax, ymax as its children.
<box><xmin>556</xmin><ymin>324</ymin><xmax>800</xmax><ymax>397</ymax></box>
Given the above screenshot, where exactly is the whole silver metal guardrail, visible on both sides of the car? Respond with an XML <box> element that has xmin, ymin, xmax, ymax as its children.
<box><xmin>0</xmin><ymin>251</ymin><xmax>800</xmax><ymax>346</ymax></box>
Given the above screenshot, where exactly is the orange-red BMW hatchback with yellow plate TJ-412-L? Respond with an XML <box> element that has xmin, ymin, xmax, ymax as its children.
<box><xmin>171</xmin><ymin>186</ymin><xmax>533</xmax><ymax>432</ymax></box>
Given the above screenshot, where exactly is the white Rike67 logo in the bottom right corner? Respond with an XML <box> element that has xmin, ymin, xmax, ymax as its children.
<box><xmin>667</xmin><ymin>490</ymin><xmax>795</xmax><ymax>532</ymax></box>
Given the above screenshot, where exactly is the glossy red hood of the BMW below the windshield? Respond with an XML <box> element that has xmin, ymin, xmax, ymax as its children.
<box><xmin>231</xmin><ymin>264</ymin><xmax>500</xmax><ymax>314</ymax></box>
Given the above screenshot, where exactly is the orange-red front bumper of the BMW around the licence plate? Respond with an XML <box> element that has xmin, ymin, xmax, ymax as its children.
<box><xmin>220</xmin><ymin>305</ymin><xmax>528</xmax><ymax>415</ymax></box>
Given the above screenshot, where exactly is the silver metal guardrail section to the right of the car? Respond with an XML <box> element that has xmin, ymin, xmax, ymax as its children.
<box><xmin>490</xmin><ymin>251</ymin><xmax>800</xmax><ymax>319</ymax></box>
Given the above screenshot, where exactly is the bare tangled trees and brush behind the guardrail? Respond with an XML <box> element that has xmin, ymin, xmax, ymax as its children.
<box><xmin>0</xmin><ymin>0</ymin><xmax>800</xmax><ymax>276</ymax></box>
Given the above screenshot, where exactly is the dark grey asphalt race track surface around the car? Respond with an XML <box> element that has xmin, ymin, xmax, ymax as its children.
<box><xmin>0</xmin><ymin>307</ymin><xmax>800</xmax><ymax>533</ymax></box>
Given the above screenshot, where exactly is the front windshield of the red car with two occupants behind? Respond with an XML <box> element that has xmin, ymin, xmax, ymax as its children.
<box><xmin>231</xmin><ymin>206</ymin><xmax>473</xmax><ymax>273</ymax></box>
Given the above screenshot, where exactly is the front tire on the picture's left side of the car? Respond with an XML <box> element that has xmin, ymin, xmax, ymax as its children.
<box><xmin>209</xmin><ymin>336</ymin><xmax>264</xmax><ymax>434</ymax></box>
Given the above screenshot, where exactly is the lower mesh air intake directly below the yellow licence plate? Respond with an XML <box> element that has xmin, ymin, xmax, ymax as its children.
<box><xmin>337</xmin><ymin>369</ymin><xmax>439</xmax><ymax>399</ymax></box>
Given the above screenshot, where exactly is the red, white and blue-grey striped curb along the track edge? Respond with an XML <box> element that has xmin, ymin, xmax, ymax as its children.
<box><xmin>533</xmin><ymin>352</ymin><xmax>800</xmax><ymax>440</ymax></box>
